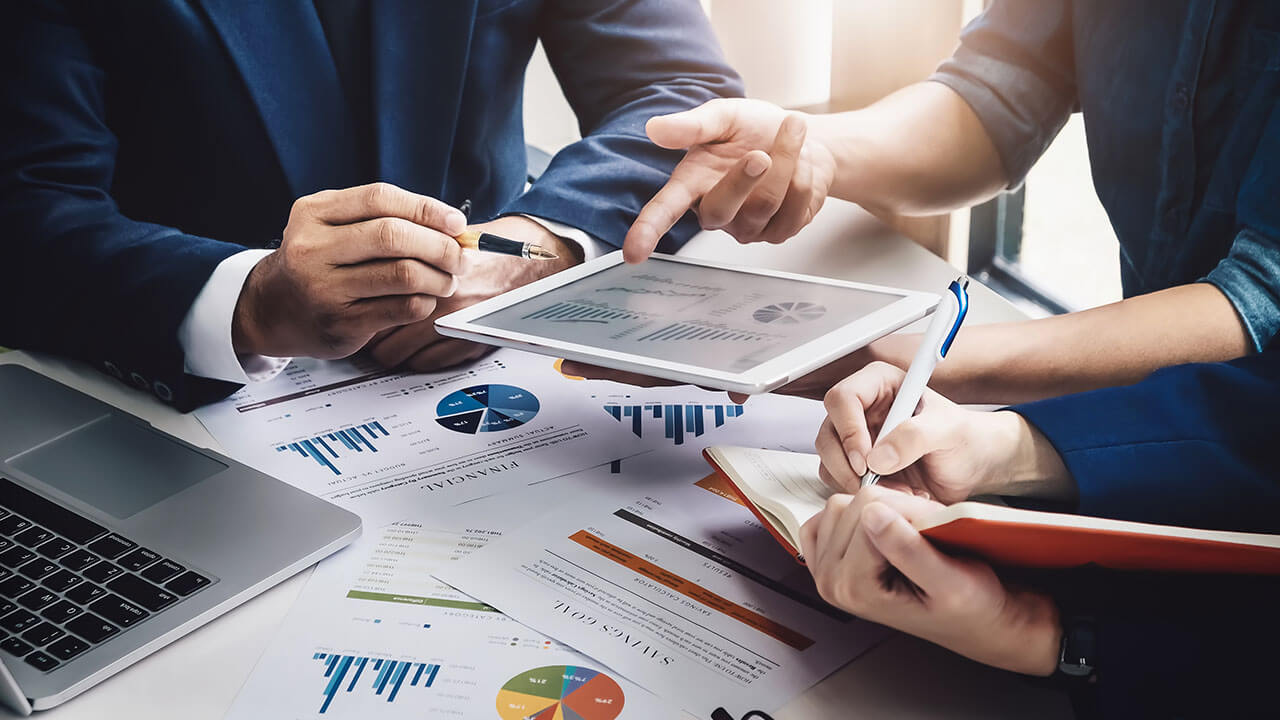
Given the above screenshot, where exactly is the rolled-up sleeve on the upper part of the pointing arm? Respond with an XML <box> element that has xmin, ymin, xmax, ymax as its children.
<box><xmin>929</xmin><ymin>0</ymin><xmax>1076</xmax><ymax>188</ymax></box>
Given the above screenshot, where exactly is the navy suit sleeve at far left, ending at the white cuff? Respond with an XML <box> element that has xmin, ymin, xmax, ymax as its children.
<box><xmin>0</xmin><ymin>3</ymin><xmax>243</xmax><ymax>410</ymax></box>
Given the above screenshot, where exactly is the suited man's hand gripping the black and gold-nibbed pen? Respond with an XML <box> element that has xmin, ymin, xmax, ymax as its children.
<box><xmin>232</xmin><ymin>183</ymin><xmax>466</xmax><ymax>359</ymax></box>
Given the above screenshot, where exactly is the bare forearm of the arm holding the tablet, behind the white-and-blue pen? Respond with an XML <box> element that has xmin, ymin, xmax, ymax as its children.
<box><xmin>870</xmin><ymin>283</ymin><xmax>1252</xmax><ymax>405</ymax></box>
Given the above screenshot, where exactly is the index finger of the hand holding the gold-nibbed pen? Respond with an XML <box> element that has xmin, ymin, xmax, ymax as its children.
<box><xmin>307</xmin><ymin>182</ymin><xmax>467</xmax><ymax>236</ymax></box>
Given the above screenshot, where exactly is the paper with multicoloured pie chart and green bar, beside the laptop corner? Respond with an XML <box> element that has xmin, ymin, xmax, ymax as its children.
<box><xmin>228</xmin><ymin>488</ymin><xmax>678</xmax><ymax>720</ymax></box>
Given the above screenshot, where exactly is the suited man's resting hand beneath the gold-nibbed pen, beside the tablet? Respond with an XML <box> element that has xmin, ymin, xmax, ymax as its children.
<box><xmin>367</xmin><ymin>215</ymin><xmax>582</xmax><ymax>370</ymax></box>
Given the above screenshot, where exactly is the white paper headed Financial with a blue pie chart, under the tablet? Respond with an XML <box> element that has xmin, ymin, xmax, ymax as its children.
<box><xmin>196</xmin><ymin>350</ymin><xmax>646</xmax><ymax>527</ymax></box>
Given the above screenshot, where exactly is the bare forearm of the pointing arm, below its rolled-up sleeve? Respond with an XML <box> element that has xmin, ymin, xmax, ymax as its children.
<box><xmin>809</xmin><ymin>82</ymin><xmax>1009</xmax><ymax>215</ymax></box>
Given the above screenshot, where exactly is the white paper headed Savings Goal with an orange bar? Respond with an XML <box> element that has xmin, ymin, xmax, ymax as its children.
<box><xmin>436</xmin><ymin>445</ymin><xmax>887</xmax><ymax>717</ymax></box>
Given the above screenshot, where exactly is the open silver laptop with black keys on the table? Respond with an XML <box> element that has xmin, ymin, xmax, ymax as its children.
<box><xmin>0</xmin><ymin>365</ymin><xmax>360</xmax><ymax>715</ymax></box>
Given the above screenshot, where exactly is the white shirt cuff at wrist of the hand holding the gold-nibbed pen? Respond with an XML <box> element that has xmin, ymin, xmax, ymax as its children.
<box><xmin>178</xmin><ymin>250</ymin><xmax>292</xmax><ymax>384</ymax></box>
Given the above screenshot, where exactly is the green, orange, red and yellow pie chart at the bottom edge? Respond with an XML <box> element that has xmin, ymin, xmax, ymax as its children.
<box><xmin>498</xmin><ymin>665</ymin><xmax>623</xmax><ymax>720</ymax></box>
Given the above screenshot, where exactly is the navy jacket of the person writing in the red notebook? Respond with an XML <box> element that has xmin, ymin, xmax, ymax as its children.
<box><xmin>1012</xmin><ymin>351</ymin><xmax>1280</xmax><ymax>719</ymax></box>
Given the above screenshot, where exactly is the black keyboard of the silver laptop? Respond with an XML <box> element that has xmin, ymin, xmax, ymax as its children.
<box><xmin>0</xmin><ymin>478</ymin><xmax>211</xmax><ymax>673</ymax></box>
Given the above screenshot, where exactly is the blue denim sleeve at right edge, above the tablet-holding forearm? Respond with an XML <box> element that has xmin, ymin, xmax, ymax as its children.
<box><xmin>1204</xmin><ymin>94</ymin><xmax>1280</xmax><ymax>351</ymax></box>
